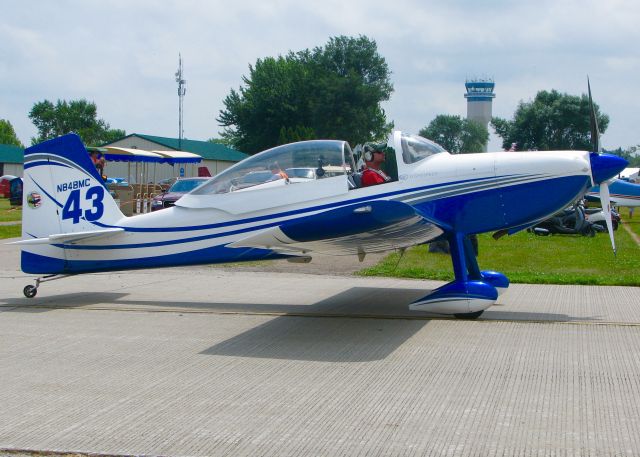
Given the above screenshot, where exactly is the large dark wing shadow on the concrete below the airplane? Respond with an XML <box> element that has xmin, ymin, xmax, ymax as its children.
<box><xmin>201</xmin><ymin>287</ymin><xmax>440</xmax><ymax>362</ymax></box>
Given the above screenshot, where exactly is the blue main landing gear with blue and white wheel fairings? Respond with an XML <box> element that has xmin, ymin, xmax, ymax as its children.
<box><xmin>409</xmin><ymin>233</ymin><xmax>509</xmax><ymax>319</ymax></box>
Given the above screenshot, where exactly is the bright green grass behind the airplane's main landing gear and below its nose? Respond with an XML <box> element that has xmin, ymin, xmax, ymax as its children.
<box><xmin>359</xmin><ymin>221</ymin><xmax>640</xmax><ymax>286</ymax></box>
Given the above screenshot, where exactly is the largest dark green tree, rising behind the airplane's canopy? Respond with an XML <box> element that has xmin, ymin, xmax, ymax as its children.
<box><xmin>217</xmin><ymin>36</ymin><xmax>393</xmax><ymax>154</ymax></box>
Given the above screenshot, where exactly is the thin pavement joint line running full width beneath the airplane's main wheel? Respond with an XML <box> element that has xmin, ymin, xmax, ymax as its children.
<box><xmin>0</xmin><ymin>305</ymin><xmax>640</xmax><ymax>327</ymax></box>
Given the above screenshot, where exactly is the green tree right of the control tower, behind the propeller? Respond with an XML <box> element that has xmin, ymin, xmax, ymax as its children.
<box><xmin>491</xmin><ymin>90</ymin><xmax>609</xmax><ymax>151</ymax></box>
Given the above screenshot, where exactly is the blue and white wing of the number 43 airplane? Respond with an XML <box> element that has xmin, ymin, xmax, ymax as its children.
<box><xmin>227</xmin><ymin>201</ymin><xmax>443</xmax><ymax>259</ymax></box>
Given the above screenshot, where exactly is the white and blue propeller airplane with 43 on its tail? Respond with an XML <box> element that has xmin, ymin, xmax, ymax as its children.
<box><xmin>16</xmin><ymin>124</ymin><xmax>627</xmax><ymax>318</ymax></box>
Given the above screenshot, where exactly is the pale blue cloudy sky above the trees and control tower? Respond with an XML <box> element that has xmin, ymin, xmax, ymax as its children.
<box><xmin>0</xmin><ymin>0</ymin><xmax>640</xmax><ymax>150</ymax></box>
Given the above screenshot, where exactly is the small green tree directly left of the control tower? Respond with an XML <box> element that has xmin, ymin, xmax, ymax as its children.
<box><xmin>419</xmin><ymin>114</ymin><xmax>489</xmax><ymax>154</ymax></box>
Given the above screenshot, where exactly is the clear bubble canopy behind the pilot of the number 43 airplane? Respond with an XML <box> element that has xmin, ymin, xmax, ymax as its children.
<box><xmin>192</xmin><ymin>140</ymin><xmax>355</xmax><ymax>195</ymax></box>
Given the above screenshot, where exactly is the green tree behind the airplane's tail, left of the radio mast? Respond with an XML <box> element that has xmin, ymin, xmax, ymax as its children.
<box><xmin>29</xmin><ymin>99</ymin><xmax>126</xmax><ymax>145</ymax></box>
